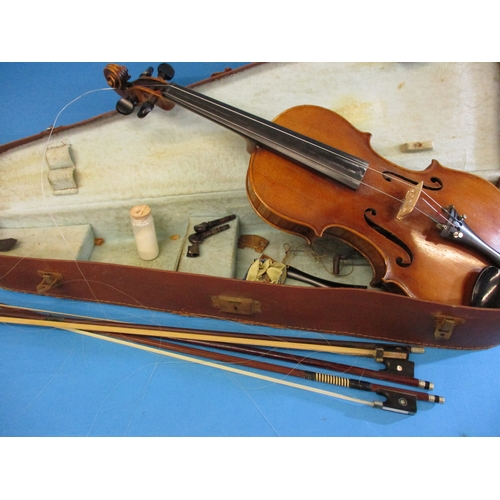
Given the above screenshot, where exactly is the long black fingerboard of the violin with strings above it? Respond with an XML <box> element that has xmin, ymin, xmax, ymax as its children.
<box><xmin>163</xmin><ymin>84</ymin><xmax>368</xmax><ymax>189</ymax></box>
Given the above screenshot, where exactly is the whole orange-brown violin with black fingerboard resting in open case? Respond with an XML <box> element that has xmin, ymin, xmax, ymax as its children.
<box><xmin>104</xmin><ymin>63</ymin><xmax>500</xmax><ymax>307</ymax></box>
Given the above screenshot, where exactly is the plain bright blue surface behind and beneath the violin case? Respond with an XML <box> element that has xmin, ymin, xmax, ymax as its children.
<box><xmin>0</xmin><ymin>61</ymin><xmax>500</xmax><ymax>437</ymax></box>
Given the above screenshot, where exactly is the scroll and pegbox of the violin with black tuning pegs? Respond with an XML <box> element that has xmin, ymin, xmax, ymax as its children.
<box><xmin>104</xmin><ymin>63</ymin><xmax>175</xmax><ymax>118</ymax></box>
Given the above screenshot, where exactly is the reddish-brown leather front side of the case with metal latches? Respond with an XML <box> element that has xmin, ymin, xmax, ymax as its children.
<box><xmin>0</xmin><ymin>256</ymin><xmax>500</xmax><ymax>349</ymax></box>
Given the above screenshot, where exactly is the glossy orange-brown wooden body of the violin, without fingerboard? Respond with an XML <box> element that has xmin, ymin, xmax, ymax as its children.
<box><xmin>247</xmin><ymin>106</ymin><xmax>500</xmax><ymax>305</ymax></box>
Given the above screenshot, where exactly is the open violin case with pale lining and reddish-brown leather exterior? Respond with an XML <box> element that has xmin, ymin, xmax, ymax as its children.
<box><xmin>0</xmin><ymin>63</ymin><xmax>500</xmax><ymax>349</ymax></box>
